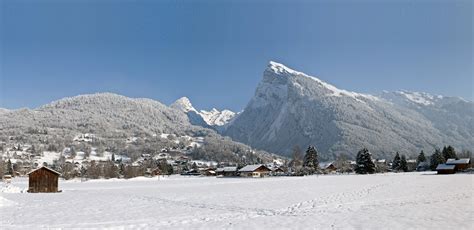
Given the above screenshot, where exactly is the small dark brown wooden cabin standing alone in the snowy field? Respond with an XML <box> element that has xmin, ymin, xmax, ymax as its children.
<box><xmin>28</xmin><ymin>166</ymin><xmax>61</xmax><ymax>193</ymax></box>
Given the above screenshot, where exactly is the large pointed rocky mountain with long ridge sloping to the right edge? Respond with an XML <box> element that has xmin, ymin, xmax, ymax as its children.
<box><xmin>223</xmin><ymin>62</ymin><xmax>474</xmax><ymax>158</ymax></box>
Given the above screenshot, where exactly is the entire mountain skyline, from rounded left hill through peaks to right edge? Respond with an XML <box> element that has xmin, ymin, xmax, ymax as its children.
<box><xmin>0</xmin><ymin>62</ymin><xmax>474</xmax><ymax>159</ymax></box>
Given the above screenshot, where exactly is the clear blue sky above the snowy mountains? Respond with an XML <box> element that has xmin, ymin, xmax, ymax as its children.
<box><xmin>0</xmin><ymin>0</ymin><xmax>474</xmax><ymax>110</ymax></box>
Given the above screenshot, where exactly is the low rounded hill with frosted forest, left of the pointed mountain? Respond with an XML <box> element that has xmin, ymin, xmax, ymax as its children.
<box><xmin>0</xmin><ymin>93</ymin><xmax>274</xmax><ymax>164</ymax></box>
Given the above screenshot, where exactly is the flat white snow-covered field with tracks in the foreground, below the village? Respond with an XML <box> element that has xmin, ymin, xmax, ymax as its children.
<box><xmin>0</xmin><ymin>173</ymin><xmax>474</xmax><ymax>229</ymax></box>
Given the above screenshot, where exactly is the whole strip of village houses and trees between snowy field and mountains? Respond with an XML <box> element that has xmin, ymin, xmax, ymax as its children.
<box><xmin>0</xmin><ymin>129</ymin><xmax>472</xmax><ymax>179</ymax></box>
